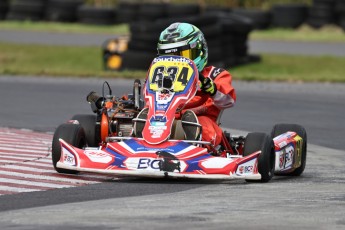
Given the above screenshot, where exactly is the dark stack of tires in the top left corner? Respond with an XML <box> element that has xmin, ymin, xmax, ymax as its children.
<box><xmin>6</xmin><ymin>0</ymin><xmax>45</xmax><ymax>21</ymax></box>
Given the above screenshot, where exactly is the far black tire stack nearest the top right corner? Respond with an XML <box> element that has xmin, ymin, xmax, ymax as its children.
<box><xmin>308</xmin><ymin>0</ymin><xmax>336</xmax><ymax>29</ymax></box>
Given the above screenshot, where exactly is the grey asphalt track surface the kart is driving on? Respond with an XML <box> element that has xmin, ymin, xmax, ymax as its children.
<box><xmin>0</xmin><ymin>76</ymin><xmax>345</xmax><ymax>229</ymax></box>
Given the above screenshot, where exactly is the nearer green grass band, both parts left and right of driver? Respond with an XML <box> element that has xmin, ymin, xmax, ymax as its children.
<box><xmin>0</xmin><ymin>43</ymin><xmax>345</xmax><ymax>82</ymax></box>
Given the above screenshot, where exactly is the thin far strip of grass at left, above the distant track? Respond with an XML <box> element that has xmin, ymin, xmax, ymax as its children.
<box><xmin>0</xmin><ymin>21</ymin><xmax>129</xmax><ymax>35</ymax></box>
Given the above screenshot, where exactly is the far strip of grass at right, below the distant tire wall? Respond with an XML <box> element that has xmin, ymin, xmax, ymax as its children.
<box><xmin>250</xmin><ymin>25</ymin><xmax>345</xmax><ymax>43</ymax></box>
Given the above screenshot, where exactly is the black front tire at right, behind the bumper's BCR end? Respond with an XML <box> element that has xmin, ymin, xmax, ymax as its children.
<box><xmin>243</xmin><ymin>133</ymin><xmax>275</xmax><ymax>182</ymax></box>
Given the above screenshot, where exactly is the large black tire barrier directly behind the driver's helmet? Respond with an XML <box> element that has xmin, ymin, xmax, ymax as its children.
<box><xmin>111</xmin><ymin>8</ymin><xmax>260</xmax><ymax>70</ymax></box>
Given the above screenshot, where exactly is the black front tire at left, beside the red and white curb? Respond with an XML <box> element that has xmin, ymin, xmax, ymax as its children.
<box><xmin>52</xmin><ymin>124</ymin><xmax>86</xmax><ymax>174</ymax></box>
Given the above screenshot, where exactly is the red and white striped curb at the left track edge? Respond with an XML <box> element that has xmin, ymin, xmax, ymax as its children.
<box><xmin>0</xmin><ymin>128</ymin><xmax>113</xmax><ymax>196</ymax></box>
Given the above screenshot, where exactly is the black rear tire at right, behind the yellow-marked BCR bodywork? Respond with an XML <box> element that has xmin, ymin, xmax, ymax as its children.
<box><xmin>271</xmin><ymin>124</ymin><xmax>307</xmax><ymax>176</ymax></box>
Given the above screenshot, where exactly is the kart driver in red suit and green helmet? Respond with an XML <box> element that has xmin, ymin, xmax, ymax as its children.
<box><xmin>134</xmin><ymin>23</ymin><xmax>236</xmax><ymax>146</ymax></box>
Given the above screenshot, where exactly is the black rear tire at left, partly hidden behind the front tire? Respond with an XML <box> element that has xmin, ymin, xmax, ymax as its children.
<box><xmin>72</xmin><ymin>114</ymin><xmax>97</xmax><ymax>147</ymax></box>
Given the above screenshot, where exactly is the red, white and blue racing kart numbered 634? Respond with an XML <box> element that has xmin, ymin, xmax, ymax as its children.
<box><xmin>52</xmin><ymin>56</ymin><xmax>307</xmax><ymax>182</ymax></box>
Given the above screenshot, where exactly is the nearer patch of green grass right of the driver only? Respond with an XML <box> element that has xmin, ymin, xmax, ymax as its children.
<box><xmin>230</xmin><ymin>54</ymin><xmax>345</xmax><ymax>83</ymax></box>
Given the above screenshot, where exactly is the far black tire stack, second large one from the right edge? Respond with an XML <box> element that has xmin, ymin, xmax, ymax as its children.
<box><xmin>272</xmin><ymin>4</ymin><xmax>308</xmax><ymax>28</ymax></box>
